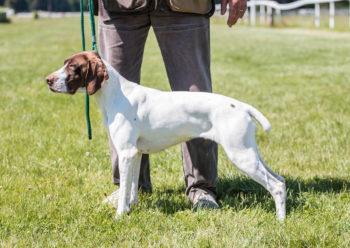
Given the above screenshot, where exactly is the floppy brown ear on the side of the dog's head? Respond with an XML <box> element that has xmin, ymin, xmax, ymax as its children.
<box><xmin>86</xmin><ymin>52</ymin><xmax>108</xmax><ymax>95</ymax></box>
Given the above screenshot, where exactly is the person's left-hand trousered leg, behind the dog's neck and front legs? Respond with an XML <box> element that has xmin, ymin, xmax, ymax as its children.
<box><xmin>98</xmin><ymin>15</ymin><xmax>152</xmax><ymax>192</ymax></box>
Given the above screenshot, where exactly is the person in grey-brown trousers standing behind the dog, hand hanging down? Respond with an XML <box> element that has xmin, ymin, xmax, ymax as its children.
<box><xmin>94</xmin><ymin>0</ymin><xmax>247</xmax><ymax>210</ymax></box>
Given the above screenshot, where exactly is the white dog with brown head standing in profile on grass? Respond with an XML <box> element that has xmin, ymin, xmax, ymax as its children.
<box><xmin>46</xmin><ymin>51</ymin><xmax>286</xmax><ymax>220</ymax></box>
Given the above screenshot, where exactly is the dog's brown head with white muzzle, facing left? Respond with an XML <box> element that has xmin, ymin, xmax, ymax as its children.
<box><xmin>46</xmin><ymin>51</ymin><xmax>108</xmax><ymax>95</ymax></box>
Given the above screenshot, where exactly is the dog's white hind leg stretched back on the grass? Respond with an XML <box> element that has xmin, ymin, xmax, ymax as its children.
<box><xmin>224</xmin><ymin>144</ymin><xmax>286</xmax><ymax>220</ymax></box>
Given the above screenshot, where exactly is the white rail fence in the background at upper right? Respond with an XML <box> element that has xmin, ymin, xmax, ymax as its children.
<box><xmin>216</xmin><ymin>0</ymin><xmax>350</xmax><ymax>29</ymax></box>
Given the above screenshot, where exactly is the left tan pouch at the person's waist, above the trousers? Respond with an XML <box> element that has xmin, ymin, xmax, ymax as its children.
<box><xmin>102</xmin><ymin>0</ymin><xmax>151</xmax><ymax>13</ymax></box>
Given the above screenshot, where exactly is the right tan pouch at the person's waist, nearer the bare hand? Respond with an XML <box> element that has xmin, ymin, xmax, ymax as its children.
<box><xmin>167</xmin><ymin>0</ymin><xmax>213</xmax><ymax>14</ymax></box>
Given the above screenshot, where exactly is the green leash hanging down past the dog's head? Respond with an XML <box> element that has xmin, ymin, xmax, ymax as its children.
<box><xmin>80</xmin><ymin>0</ymin><xmax>98</xmax><ymax>140</ymax></box>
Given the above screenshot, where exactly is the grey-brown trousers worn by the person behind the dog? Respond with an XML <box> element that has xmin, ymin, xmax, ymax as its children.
<box><xmin>99</xmin><ymin>3</ymin><xmax>218</xmax><ymax>201</ymax></box>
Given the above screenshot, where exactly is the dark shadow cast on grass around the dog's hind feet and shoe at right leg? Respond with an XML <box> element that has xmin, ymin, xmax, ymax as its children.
<box><xmin>142</xmin><ymin>177</ymin><xmax>350</xmax><ymax>215</ymax></box>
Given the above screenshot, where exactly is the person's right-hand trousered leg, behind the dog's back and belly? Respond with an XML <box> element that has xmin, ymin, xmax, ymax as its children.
<box><xmin>151</xmin><ymin>6</ymin><xmax>218</xmax><ymax>207</ymax></box>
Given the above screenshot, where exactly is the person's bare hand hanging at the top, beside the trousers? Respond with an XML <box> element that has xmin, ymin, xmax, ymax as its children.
<box><xmin>221</xmin><ymin>0</ymin><xmax>247</xmax><ymax>27</ymax></box>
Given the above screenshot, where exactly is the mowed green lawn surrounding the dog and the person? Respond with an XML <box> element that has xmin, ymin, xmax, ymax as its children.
<box><xmin>0</xmin><ymin>18</ymin><xmax>350</xmax><ymax>247</ymax></box>
